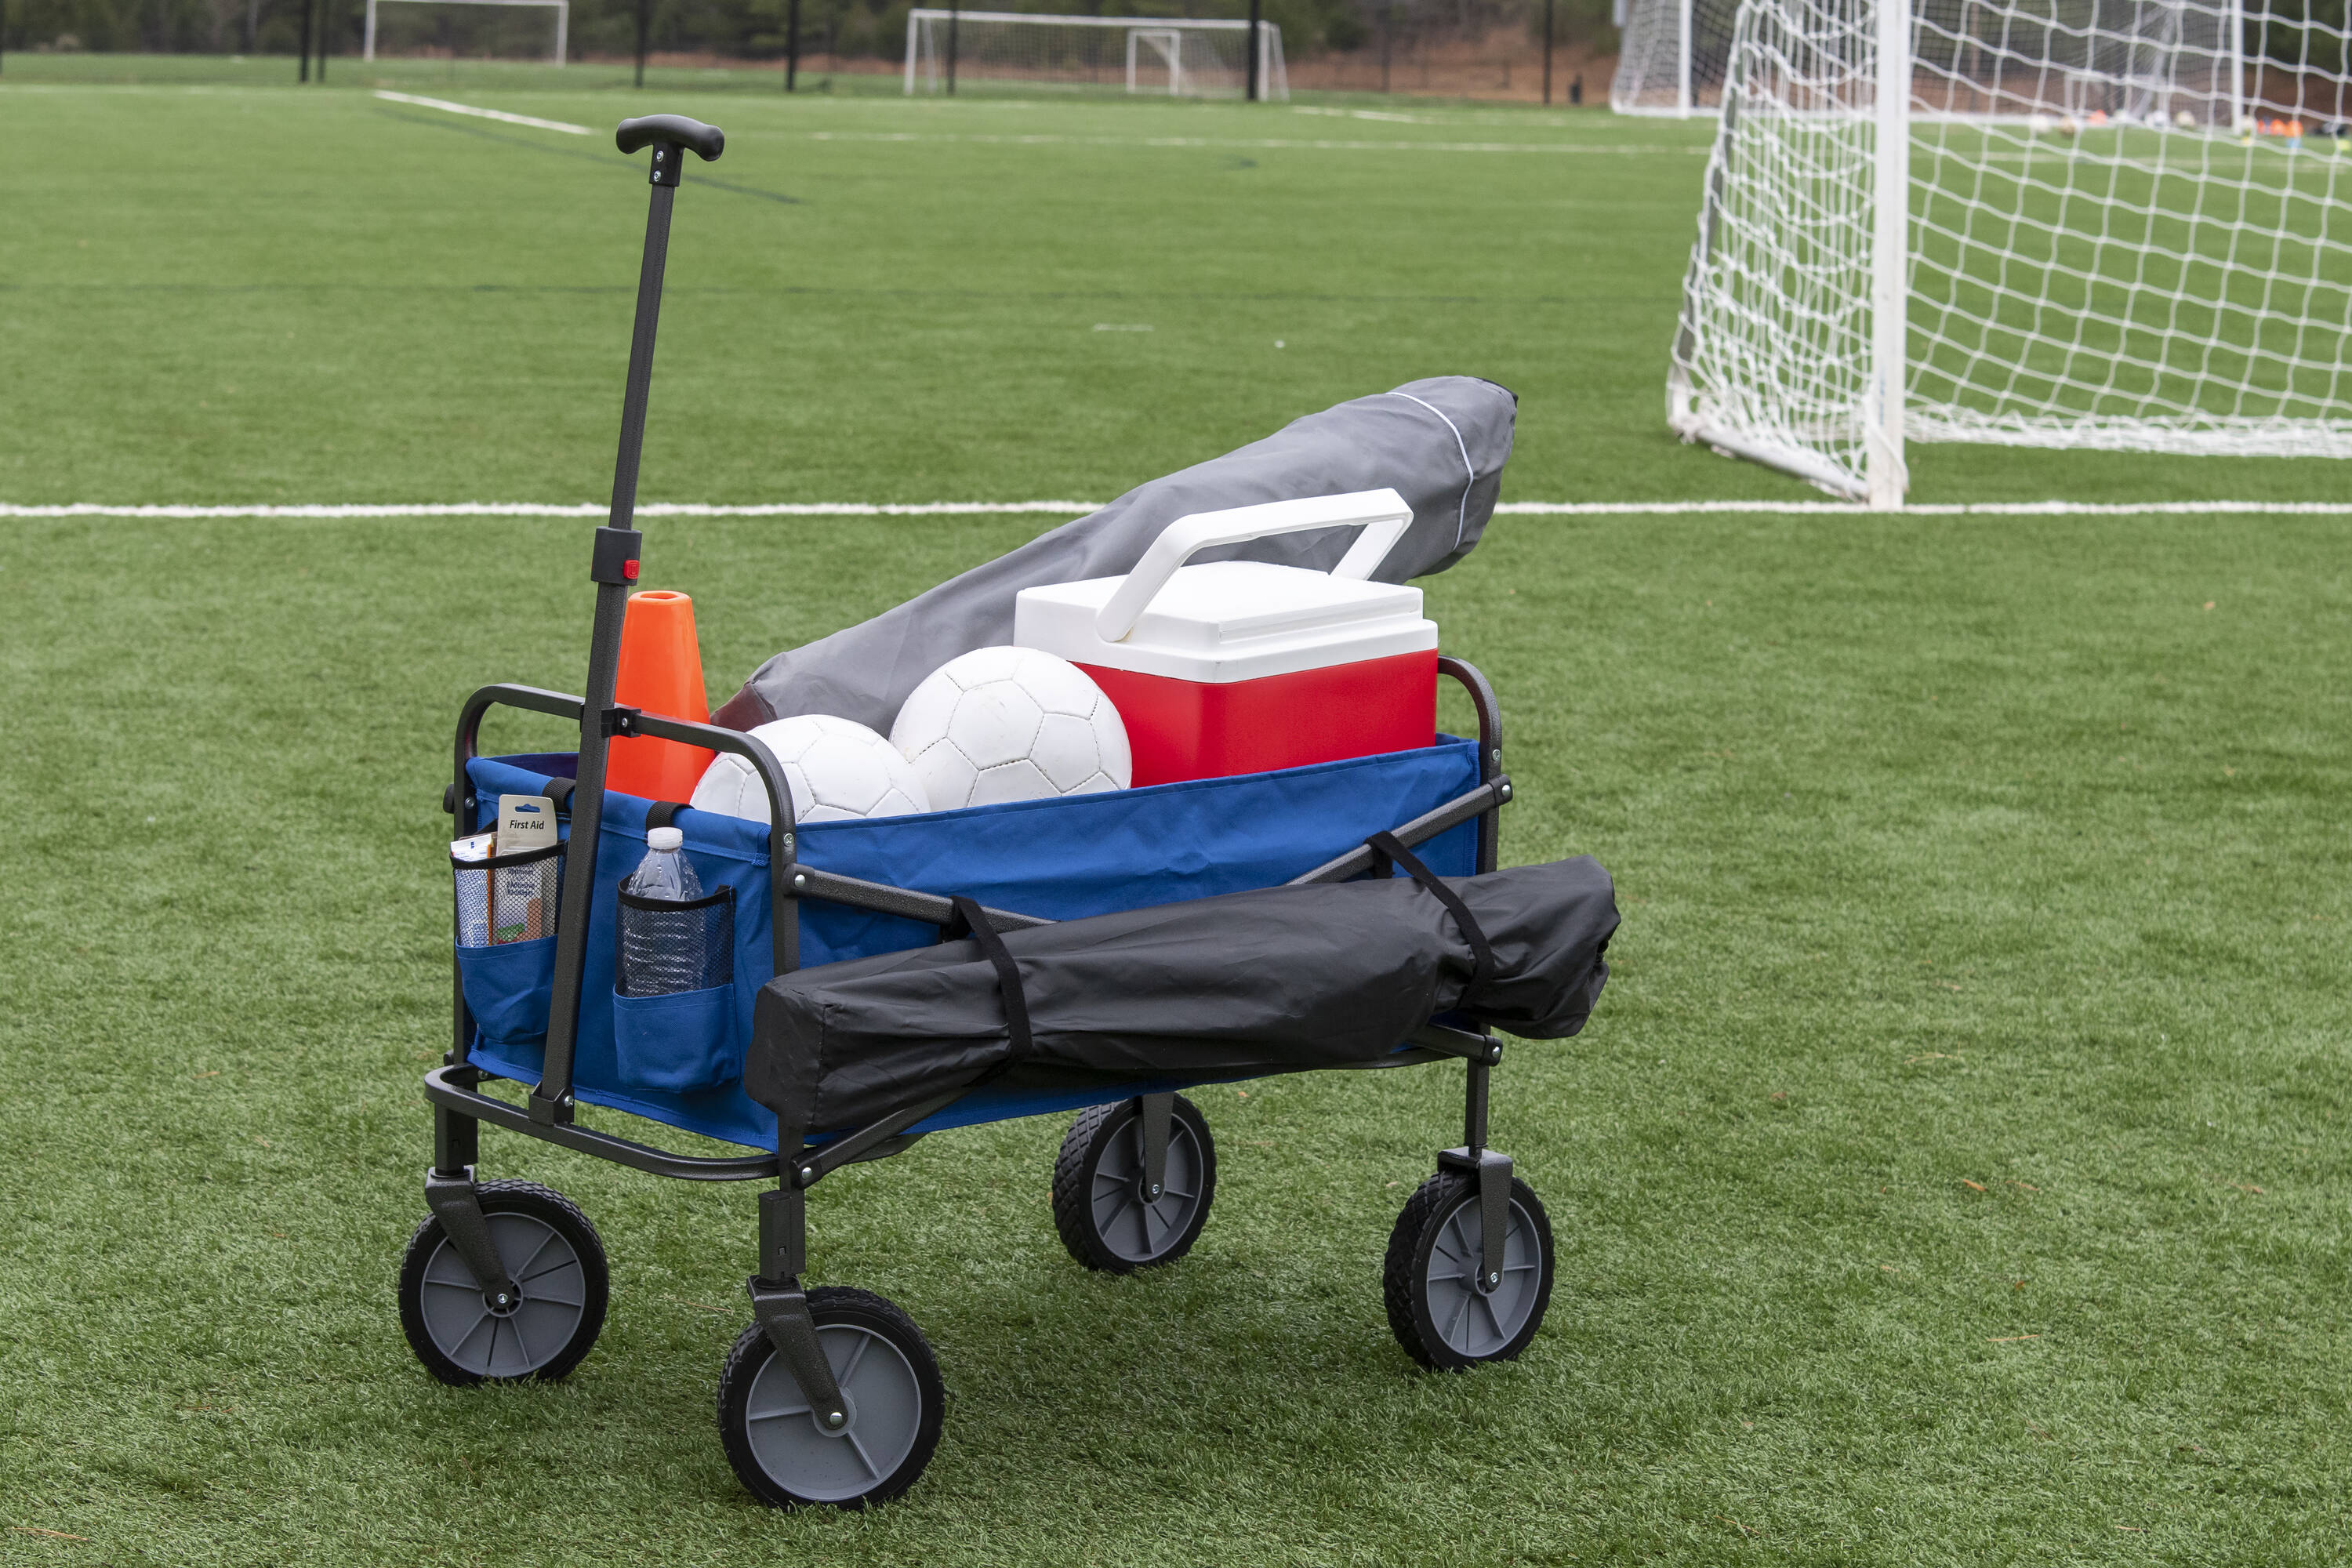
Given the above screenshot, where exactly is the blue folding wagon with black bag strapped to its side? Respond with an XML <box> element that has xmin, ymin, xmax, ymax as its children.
<box><xmin>400</xmin><ymin>115</ymin><xmax>1616</xmax><ymax>1507</ymax></box>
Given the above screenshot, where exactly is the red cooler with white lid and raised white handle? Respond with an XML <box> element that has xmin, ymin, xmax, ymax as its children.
<box><xmin>1014</xmin><ymin>489</ymin><xmax>1437</xmax><ymax>785</ymax></box>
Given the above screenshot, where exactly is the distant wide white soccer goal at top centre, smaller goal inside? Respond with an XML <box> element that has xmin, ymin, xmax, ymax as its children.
<box><xmin>906</xmin><ymin>9</ymin><xmax>1291</xmax><ymax>99</ymax></box>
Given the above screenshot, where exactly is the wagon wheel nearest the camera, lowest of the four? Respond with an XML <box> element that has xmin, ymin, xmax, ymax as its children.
<box><xmin>720</xmin><ymin>1286</ymin><xmax>948</xmax><ymax>1509</ymax></box>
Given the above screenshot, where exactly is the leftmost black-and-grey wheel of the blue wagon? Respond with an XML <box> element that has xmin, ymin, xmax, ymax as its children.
<box><xmin>400</xmin><ymin>1180</ymin><xmax>612</xmax><ymax>1387</ymax></box>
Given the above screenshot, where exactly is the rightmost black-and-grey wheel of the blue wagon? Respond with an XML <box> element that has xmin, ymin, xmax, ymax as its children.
<box><xmin>1381</xmin><ymin>1171</ymin><xmax>1552</xmax><ymax>1373</ymax></box>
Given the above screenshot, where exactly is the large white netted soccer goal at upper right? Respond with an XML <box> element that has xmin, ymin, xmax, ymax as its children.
<box><xmin>1668</xmin><ymin>0</ymin><xmax>2352</xmax><ymax>506</ymax></box>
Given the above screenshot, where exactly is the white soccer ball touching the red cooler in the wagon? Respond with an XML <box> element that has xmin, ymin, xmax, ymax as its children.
<box><xmin>889</xmin><ymin>649</ymin><xmax>1134</xmax><ymax>811</ymax></box>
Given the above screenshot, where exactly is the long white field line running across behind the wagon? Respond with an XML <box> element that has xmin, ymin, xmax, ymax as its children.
<box><xmin>13</xmin><ymin>501</ymin><xmax>2352</xmax><ymax>522</ymax></box>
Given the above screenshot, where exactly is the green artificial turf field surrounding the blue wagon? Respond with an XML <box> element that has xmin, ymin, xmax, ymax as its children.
<box><xmin>0</xmin><ymin>70</ymin><xmax>2352</xmax><ymax>1566</ymax></box>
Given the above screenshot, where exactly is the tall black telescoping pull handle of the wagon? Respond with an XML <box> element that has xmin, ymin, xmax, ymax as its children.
<box><xmin>529</xmin><ymin>115</ymin><xmax>727</xmax><ymax>1123</ymax></box>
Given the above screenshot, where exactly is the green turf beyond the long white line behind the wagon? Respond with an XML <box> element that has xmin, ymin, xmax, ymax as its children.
<box><xmin>0</xmin><ymin>74</ymin><xmax>2345</xmax><ymax>503</ymax></box>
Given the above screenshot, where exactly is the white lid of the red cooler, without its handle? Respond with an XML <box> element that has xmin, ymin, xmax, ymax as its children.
<box><xmin>1014</xmin><ymin>562</ymin><xmax>1437</xmax><ymax>684</ymax></box>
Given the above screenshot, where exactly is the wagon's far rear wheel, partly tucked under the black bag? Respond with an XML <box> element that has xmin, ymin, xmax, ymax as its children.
<box><xmin>1054</xmin><ymin>1095</ymin><xmax>1216</xmax><ymax>1274</ymax></box>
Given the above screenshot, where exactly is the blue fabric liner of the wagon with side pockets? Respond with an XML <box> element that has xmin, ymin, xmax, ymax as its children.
<box><xmin>459</xmin><ymin>736</ymin><xmax>1479</xmax><ymax>1149</ymax></box>
